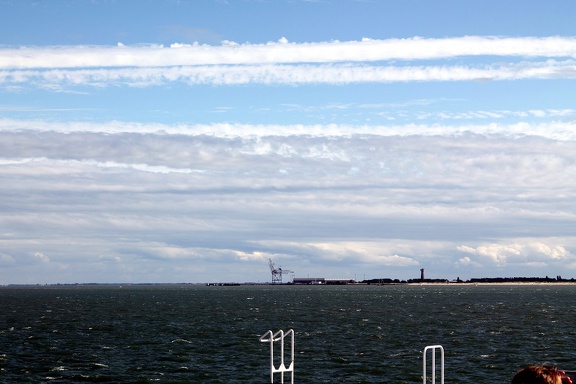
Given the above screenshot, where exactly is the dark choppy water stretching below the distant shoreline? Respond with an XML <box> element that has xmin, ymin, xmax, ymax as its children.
<box><xmin>0</xmin><ymin>285</ymin><xmax>576</xmax><ymax>384</ymax></box>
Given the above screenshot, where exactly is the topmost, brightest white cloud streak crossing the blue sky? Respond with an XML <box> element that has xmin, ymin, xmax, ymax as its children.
<box><xmin>0</xmin><ymin>36</ymin><xmax>576</xmax><ymax>69</ymax></box>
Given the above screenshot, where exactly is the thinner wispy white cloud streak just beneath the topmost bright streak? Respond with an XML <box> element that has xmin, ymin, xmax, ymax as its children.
<box><xmin>0</xmin><ymin>60</ymin><xmax>576</xmax><ymax>89</ymax></box>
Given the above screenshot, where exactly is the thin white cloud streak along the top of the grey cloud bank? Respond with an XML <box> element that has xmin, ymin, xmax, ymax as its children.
<box><xmin>0</xmin><ymin>118</ymin><xmax>576</xmax><ymax>141</ymax></box>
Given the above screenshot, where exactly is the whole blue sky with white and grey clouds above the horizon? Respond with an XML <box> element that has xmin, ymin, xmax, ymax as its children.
<box><xmin>0</xmin><ymin>0</ymin><xmax>576</xmax><ymax>285</ymax></box>
